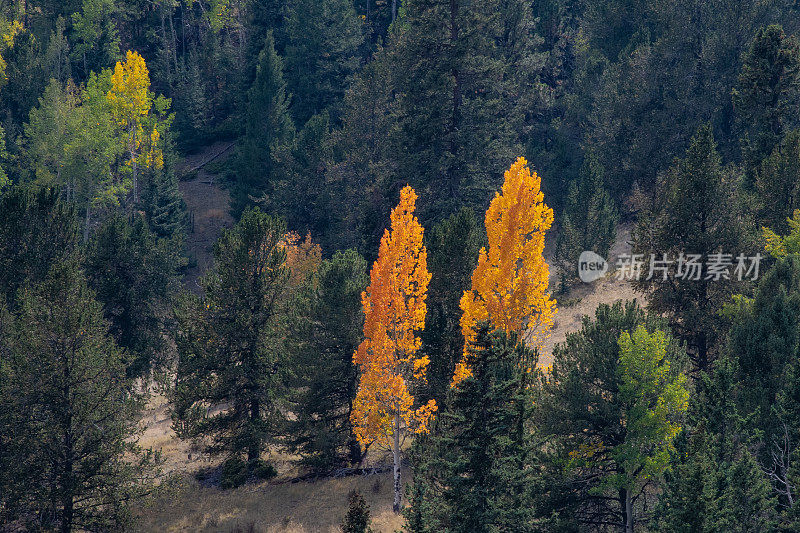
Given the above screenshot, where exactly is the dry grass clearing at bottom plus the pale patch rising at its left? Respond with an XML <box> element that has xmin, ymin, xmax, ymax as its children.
<box><xmin>136</xmin><ymin>388</ymin><xmax>408</xmax><ymax>533</ymax></box>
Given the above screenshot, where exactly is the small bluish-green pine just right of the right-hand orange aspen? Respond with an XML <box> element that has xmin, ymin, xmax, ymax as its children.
<box><xmin>556</xmin><ymin>153</ymin><xmax>619</xmax><ymax>284</ymax></box>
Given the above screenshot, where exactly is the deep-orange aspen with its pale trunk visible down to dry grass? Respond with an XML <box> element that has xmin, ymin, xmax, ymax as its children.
<box><xmin>351</xmin><ymin>186</ymin><xmax>436</xmax><ymax>513</ymax></box>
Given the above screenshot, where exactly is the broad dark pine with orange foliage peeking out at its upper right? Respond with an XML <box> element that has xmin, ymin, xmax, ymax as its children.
<box><xmin>174</xmin><ymin>208</ymin><xmax>292</xmax><ymax>473</ymax></box>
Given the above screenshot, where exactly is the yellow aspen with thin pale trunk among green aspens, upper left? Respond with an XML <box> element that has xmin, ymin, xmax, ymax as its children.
<box><xmin>106</xmin><ymin>50</ymin><xmax>153</xmax><ymax>204</ymax></box>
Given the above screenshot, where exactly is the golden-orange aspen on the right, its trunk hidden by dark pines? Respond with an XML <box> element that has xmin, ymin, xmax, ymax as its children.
<box><xmin>453</xmin><ymin>157</ymin><xmax>556</xmax><ymax>385</ymax></box>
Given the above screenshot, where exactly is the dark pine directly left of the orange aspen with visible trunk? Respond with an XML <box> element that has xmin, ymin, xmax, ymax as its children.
<box><xmin>291</xmin><ymin>250</ymin><xmax>369</xmax><ymax>471</ymax></box>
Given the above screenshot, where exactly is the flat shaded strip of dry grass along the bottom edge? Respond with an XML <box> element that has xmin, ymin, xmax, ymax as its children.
<box><xmin>137</xmin><ymin>473</ymin><xmax>403</xmax><ymax>533</ymax></box>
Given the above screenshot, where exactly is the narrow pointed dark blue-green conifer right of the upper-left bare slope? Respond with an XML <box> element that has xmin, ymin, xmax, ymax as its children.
<box><xmin>232</xmin><ymin>32</ymin><xmax>295</xmax><ymax>214</ymax></box>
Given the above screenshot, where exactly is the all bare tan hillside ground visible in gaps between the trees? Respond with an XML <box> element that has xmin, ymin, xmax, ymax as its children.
<box><xmin>131</xmin><ymin>156</ymin><xmax>637</xmax><ymax>533</ymax></box>
